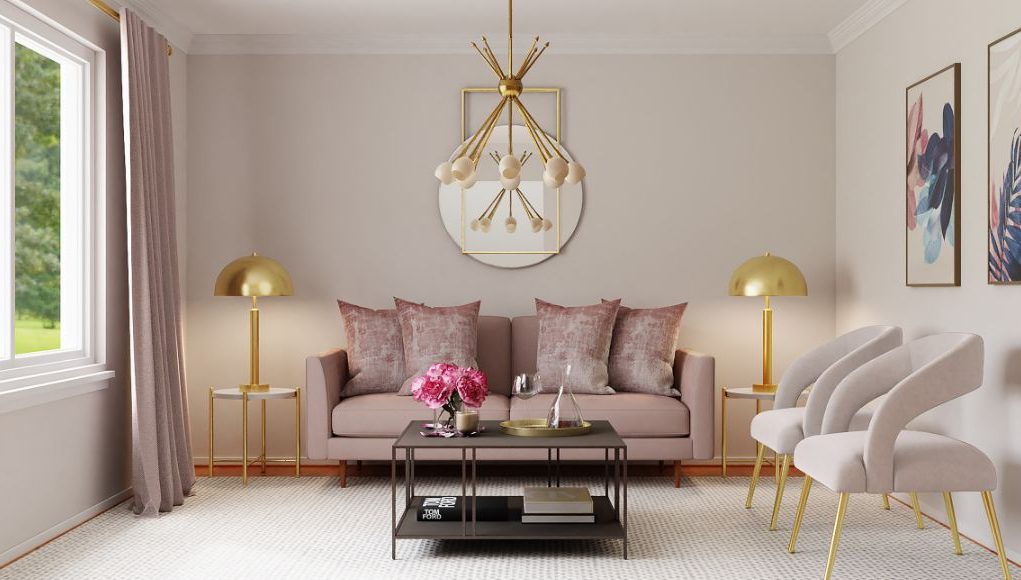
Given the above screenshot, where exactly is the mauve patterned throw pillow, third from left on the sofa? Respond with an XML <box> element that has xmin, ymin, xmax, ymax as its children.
<box><xmin>535</xmin><ymin>298</ymin><xmax>621</xmax><ymax>395</ymax></box>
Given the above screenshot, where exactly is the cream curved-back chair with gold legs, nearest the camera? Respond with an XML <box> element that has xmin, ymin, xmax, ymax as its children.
<box><xmin>788</xmin><ymin>333</ymin><xmax>1011</xmax><ymax>580</ymax></box>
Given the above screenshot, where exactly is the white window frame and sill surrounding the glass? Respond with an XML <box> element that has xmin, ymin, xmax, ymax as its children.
<box><xmin>0</xmin><ymin>2</ymin><xmax>112</xmax><ymax>398</ymax></box>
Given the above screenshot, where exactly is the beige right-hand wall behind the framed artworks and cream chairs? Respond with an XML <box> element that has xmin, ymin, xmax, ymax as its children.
<box><xmin>836</xmin><ymin>0</ymin><xmax>1021</xmax><ymax>558</ymax></box>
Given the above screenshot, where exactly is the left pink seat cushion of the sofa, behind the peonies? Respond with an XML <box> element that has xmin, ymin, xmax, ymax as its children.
<box><xmin>333</xmin><ymin>392</ymin><xmax>509</xmax><ymax>437</ymax></box>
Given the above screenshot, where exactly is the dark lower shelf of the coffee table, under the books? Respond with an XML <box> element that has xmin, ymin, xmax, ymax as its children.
<box><xmin>395</xmin><ymin>495</ymin><xmax>625</xmax><ymax>540</ymax></box>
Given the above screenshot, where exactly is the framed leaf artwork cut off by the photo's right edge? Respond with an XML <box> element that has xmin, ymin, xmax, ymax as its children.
<box><xmin>988</xmin><ymin>30</ymin><xmax>1021</xmax><ymax>284</ymax></box>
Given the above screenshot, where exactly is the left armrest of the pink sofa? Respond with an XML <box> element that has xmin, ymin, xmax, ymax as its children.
<box><xmin>304</xmin><ymin>348</ymin><xmax>347</xmax><ymax>460</ymax></box>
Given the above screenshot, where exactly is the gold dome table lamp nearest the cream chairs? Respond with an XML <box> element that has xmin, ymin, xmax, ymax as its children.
<box><xmin>730</xmin><ymin>252</ymin><xmax>809</xmax><ymax>393</ymax></box>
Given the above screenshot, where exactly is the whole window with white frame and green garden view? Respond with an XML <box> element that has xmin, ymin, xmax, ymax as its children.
<box><xmin>0</xmin><ymin>2</ymin><xmax>95</xmax><ymax>391</ymax></box>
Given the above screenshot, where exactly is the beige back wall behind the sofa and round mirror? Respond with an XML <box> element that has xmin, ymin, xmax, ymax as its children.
<box><xmin>187</xmin><ymin>53</ymin><xmax>834</xmax><ymax>461</ymax></box>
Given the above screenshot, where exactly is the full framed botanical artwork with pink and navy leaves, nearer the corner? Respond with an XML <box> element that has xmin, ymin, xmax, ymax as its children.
<box><xmin>905</xmin><ymin>63</ymin><xmax>961</xmax><ymax>286</ymax></box>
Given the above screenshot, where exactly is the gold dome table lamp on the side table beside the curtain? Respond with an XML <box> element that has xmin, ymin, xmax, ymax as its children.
<box><xmin>212</xmin><ymin>253</ymin><xmax>294</xmax><ymax>392</ymax></box>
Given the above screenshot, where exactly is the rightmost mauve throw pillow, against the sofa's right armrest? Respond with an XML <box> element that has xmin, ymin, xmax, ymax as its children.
<box><xmin>603</xmin><ymin>300</ymin><xmax>688</xmax><ymax>396</ymax></box>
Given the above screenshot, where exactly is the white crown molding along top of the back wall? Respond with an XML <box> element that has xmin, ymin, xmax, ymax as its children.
<box><xmin>189</xmin><ymin>35</ymin><xmax>832</xmax><ymax>54</ymax></box>
